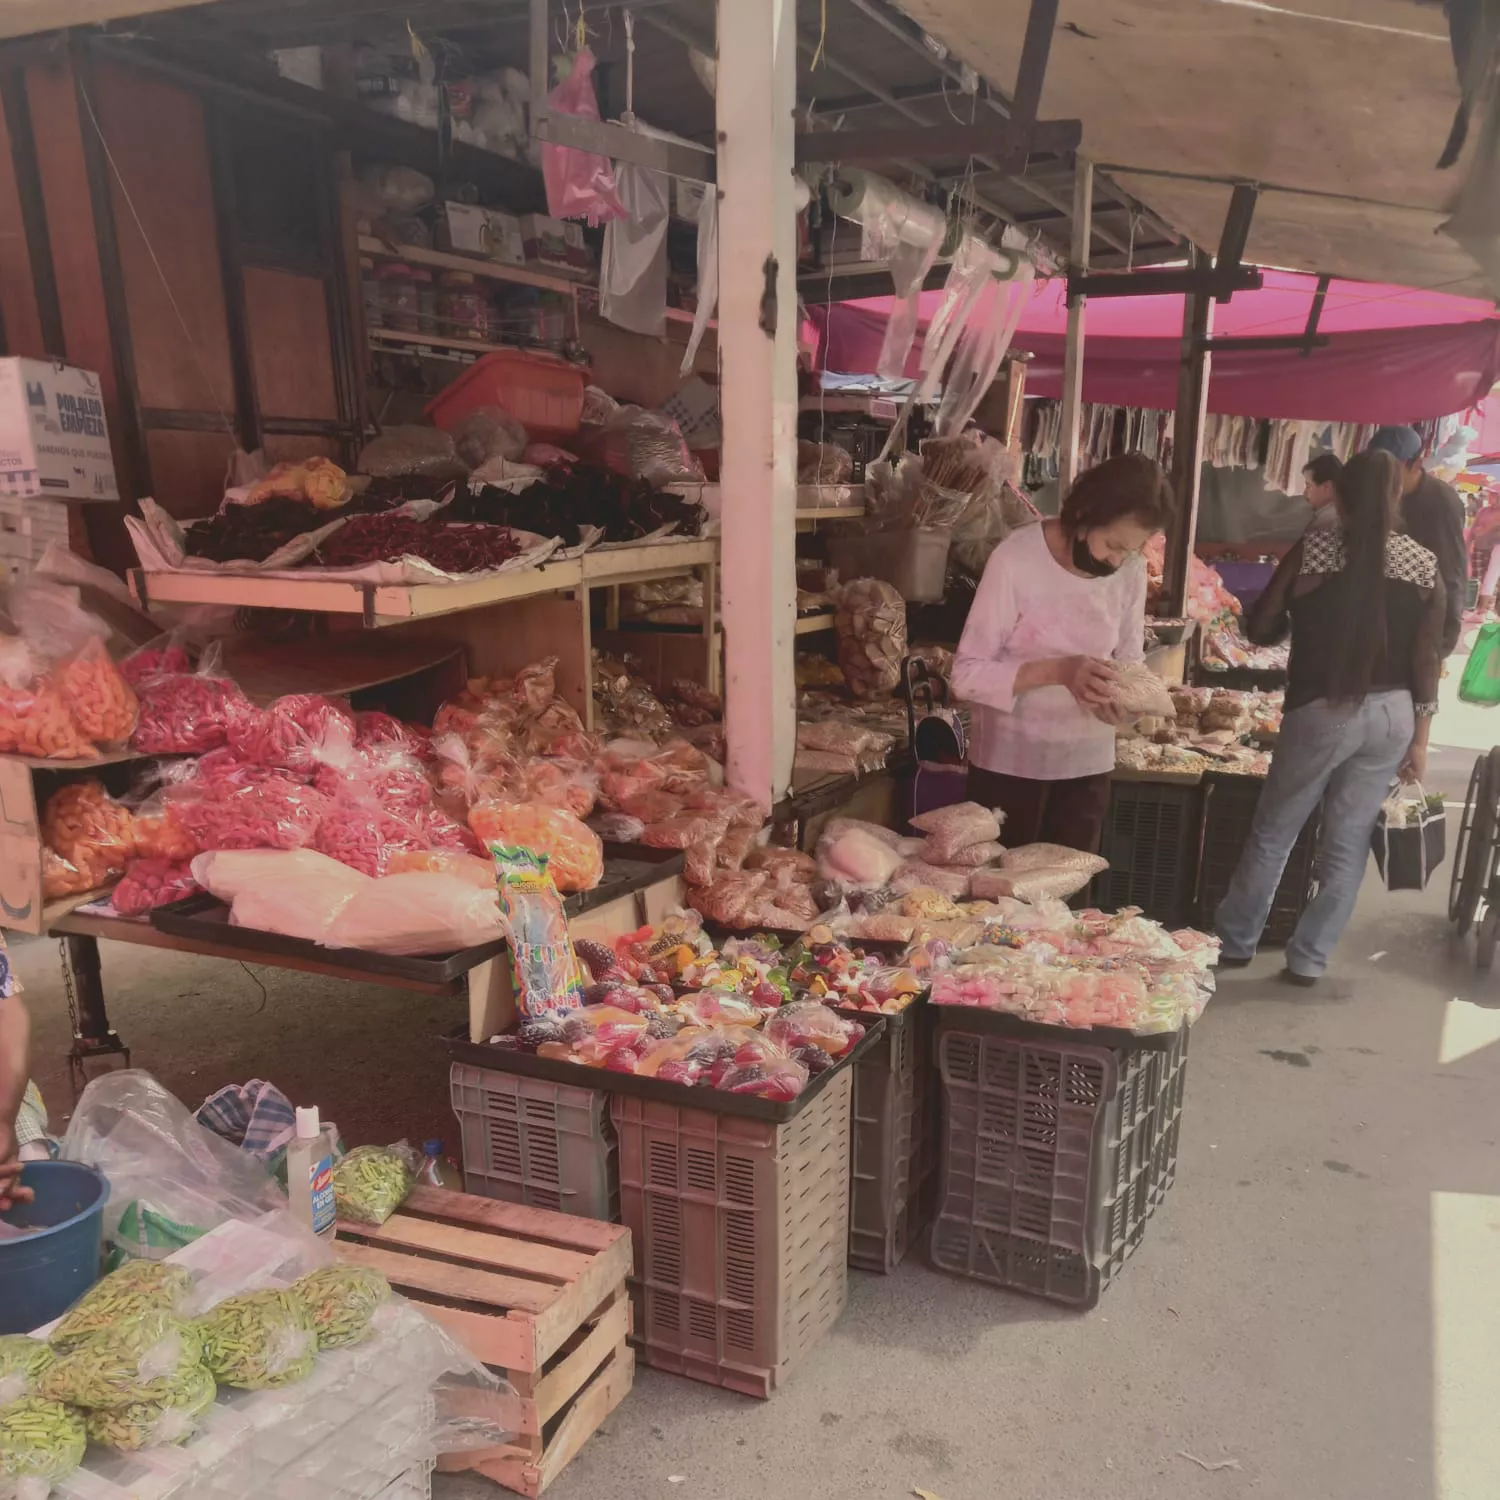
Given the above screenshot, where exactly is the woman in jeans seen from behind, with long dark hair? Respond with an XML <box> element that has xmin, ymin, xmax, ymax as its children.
<box><xmin>1214</xmin><ymin>452</ymin><xmax>1446</xmax><ymax>986</ymax></box>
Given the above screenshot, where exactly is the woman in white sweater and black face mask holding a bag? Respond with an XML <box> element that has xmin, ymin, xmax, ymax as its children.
<box><xmin>953</xmin><ymin>453</ymin><xmax>1173</xmax><ymax>854</ymax></box>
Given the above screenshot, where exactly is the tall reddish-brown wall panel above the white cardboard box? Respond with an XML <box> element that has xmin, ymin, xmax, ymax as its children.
<box><xmin>95</xmin><ymin>63</ymin><xmax>234</xmax><ymax>413</ymax></box>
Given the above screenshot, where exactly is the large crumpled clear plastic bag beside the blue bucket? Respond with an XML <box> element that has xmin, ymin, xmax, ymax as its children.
<box><xmin>54</xmin><ymin>1068</ymin><xmax>287</xmax><ymax>1254</ymax></box>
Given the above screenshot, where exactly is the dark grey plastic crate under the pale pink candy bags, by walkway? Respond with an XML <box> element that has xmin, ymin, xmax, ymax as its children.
<box><xmin>932</xmin><ymin>1016</ymin><xmax>1188</xmax><ymax>1308</ymax></box>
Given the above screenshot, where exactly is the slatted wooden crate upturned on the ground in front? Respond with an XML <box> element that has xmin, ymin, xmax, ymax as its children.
<box><xmin>338</xmin><ymin>1187</ymin><xmax>636</xmax><ymax>1496</ymax></box>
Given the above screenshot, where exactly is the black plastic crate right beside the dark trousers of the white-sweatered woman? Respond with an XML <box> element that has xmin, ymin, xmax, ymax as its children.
<box><xmin>1089</xmin><ymin>782</ymin><xmax>1202</xmax><ymax>927</ymax></box>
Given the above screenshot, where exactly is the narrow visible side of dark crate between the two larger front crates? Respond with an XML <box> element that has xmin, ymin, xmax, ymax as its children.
<box><xmin>845</xmin><ymin>1002</ymin><xmax>938</xmax><ymax>1275</ymax></box>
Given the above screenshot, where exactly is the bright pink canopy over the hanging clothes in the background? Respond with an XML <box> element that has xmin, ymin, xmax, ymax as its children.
<box><xmin>812</xmin><ymin>272</ymin><xmax>1500</xmax><ymax>422</ymax></box>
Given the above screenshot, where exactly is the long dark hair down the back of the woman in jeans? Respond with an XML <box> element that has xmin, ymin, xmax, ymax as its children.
<box><xmin>1329</xmin><ymin>452</ymin><xmax>1401</xmax><ymax>704</ymax></box>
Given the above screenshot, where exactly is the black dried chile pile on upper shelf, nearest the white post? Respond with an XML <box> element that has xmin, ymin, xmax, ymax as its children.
<box><xmin>452</xmin><ymin>464</ymin><xmax>704</xmax><ymax>546</ymax></box>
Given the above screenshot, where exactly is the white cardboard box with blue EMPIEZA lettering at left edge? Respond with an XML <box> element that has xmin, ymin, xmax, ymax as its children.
<box><xmin>0</xmin><ymin>359</ymin><xmax>120</xmax><ymax>500</ymax></box>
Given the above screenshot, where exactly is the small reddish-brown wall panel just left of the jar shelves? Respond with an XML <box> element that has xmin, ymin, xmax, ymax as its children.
<box><xmin>245</xmin><ymin>266</ymin><xmax>339</xmax><ymax>422</ymax></box>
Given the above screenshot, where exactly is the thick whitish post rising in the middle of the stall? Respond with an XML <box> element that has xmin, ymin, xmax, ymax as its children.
<box><xmin>710</xmin><ymin>0</ymin><xmax>798</xmax><ymax>807</ymax></box>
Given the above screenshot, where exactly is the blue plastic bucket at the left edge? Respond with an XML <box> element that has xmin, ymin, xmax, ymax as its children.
<box><xmin>0</xmin><ymin>1161</ymin><xmax>110</xmax><ymax>1334</ymax></box>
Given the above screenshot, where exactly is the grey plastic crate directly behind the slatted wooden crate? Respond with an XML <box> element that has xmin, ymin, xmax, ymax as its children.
<box><xmin>449</xmin><ymin>1062</ymin><xmax>620</xmax><ymax>1224</ymax></box>
